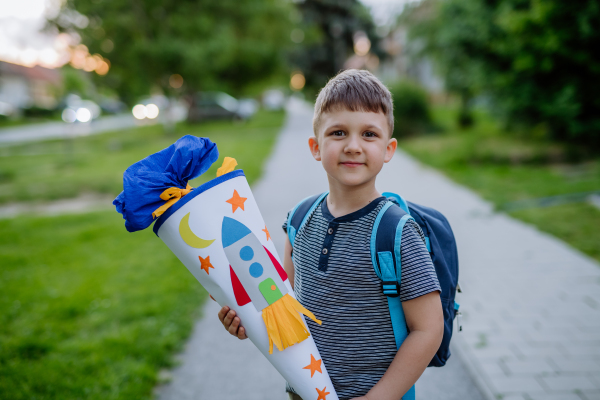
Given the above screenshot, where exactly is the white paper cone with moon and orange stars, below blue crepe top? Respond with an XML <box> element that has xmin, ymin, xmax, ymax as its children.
<box><xmin>155</xmin><ymin>170</ymin><xmax>338</xmax><ymax>400</ymax></box>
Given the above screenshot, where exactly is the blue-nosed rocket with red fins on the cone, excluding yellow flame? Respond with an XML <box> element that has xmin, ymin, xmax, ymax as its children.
<box><xmin>222</xmin><ymin>217</ymin><xmax>288</xmax><ymax>311</ymax></box>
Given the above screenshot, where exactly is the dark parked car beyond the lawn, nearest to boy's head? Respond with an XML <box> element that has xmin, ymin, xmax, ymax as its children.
<box><xmin>188</xmin><ymin>92</ymin><xmax>258</xmax><ymax>122</ymax></box>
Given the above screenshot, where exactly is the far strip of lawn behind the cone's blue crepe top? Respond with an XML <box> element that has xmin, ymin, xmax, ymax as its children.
<box><xmin>0</xmin><ymin>111</ymin><xmax>284</xmax><ymax>204</ymax></box>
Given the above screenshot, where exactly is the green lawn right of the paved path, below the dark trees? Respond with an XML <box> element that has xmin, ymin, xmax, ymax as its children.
<box><xmin>400</xmin><ymin>109</ymin><xmax>600</xmax><ymax>260</ymax></box>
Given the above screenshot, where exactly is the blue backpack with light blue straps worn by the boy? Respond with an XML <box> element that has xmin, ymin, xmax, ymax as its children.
<box><xmin>287</xmin><ymin>192</ymin><xmax>462</xmax><ymax>400</ymax></box>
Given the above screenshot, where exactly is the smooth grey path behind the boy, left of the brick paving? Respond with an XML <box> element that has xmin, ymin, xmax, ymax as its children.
<box><xmin>157</xmin><ymin>100</ymin><xmax>483</xmax><ymax>400</ymax></box>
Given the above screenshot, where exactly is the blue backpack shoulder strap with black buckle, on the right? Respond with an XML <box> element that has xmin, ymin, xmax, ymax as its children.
<box><xmin>371</xmin><ymin>193</ymin><xmax>415</xmax><ymax>400</ymax></box>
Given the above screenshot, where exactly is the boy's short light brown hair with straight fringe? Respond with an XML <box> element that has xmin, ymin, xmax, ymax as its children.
<box><xmin>313</xmin><ymin>69</ymin><xmax>394</xmax><ymax>137</ymax></box>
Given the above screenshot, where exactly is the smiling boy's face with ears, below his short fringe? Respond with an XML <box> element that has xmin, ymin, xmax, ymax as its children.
<box><xmin>309</xmin><ymin>109</ymin><xmax>397</xmax><ymax>191</ymax></box>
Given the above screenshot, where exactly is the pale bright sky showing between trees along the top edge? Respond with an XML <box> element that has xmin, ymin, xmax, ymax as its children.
<box><xmin>0</xmin><ymin>0</ymin><xmax>414</xmax><ymax>68</ymax></box>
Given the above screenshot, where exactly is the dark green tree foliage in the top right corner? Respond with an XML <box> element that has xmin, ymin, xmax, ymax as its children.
<box><xmin>403</xmin><ymin>0</ymin><xmax>600</xmax><ymax>148</ymax></box>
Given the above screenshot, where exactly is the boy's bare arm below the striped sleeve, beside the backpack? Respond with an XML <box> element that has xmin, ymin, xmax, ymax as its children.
<box><xmin>361</xmin><ymin>291</ymin><xmax>444</xmax><ymax>400</ymax></box>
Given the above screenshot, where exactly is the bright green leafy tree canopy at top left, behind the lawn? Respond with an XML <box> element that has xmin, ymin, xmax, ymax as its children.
<box><xmin>50</xmin><ymin>0</ymin><xmax>292</xmax><ymax>102</ymax></box>
